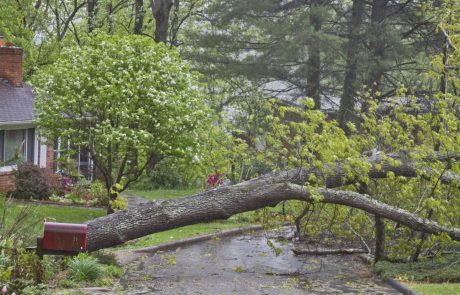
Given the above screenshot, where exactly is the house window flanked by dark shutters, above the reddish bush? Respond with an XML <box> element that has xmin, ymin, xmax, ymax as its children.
<box><xmin>0</xmin><ymin>128</ymin><xmax>35</xmax><ymax>165</ymax></box>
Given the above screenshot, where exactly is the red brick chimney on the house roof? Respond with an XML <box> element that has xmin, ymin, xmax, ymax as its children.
<box><xmin>0</xmin><ymin>36</ymin><xmax>22</xmax><ymax>87</ymax></box>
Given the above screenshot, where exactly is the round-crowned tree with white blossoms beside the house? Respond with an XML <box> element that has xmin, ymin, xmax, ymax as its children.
<box><xmin>33</xmin><ymin>34</ymin><xmax>206</xmax><ymax>205</ymax></box>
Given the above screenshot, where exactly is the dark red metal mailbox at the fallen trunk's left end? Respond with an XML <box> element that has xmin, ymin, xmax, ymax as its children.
<box><xmin>42</xmin><ymin>222</ymin><xmax>87</xmax><ymax>252</ymax></box>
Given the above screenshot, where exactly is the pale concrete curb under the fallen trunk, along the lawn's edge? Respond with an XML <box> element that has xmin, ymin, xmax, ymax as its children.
<box><xmin>114</xmin><ymin>225</ymin><xmax>263</xmax><ymax>266</ymax></box>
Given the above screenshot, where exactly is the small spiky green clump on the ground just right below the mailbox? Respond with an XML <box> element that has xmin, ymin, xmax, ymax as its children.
<box><xmin>69</xmin><ymin>254</ymin><xmax>103</xmax><ymax>282</ymax></box>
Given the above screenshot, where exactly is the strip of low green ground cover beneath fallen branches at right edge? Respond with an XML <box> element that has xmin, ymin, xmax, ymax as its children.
<box><xmin>375</xmin><ymin>254</ymin><xmax>460</xmax><ymax>283</ymax></box>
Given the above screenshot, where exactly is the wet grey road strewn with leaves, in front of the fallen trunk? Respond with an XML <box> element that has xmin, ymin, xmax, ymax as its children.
<box><xmin>121</xmin><ymin>232</ymin><xmax>399</xmax><ymax>295</ymax></box>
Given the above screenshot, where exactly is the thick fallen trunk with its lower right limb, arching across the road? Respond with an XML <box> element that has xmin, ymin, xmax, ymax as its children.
<box><xmin>87</xmin><ymin>173</ymin><xmax>460</xmax><ymax>251</ymax></box>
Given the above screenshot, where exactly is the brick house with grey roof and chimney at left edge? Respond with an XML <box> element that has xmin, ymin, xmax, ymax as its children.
<box><xmin>0</xmin><ymin>36</ymin><xmax>54</xmax><ymax>192</ymax></box>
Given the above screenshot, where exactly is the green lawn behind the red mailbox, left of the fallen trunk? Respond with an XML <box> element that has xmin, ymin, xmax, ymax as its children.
<box><xmin>0</xmin><ymin>198</ymin><xmax>106</xmax><ymax>245</ymax></box>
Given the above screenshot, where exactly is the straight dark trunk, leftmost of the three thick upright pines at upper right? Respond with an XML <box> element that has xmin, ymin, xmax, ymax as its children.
<box><xmin>307</xmin><ymin>0</ymin><xmax>323</xmax><ymax>109</ymax></box>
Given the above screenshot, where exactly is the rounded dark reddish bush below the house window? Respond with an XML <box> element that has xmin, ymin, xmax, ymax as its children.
<box><xmin>13</xmin><ymin>163</ymin><xmax>52</xmax><ymax>200</ymax></box>
